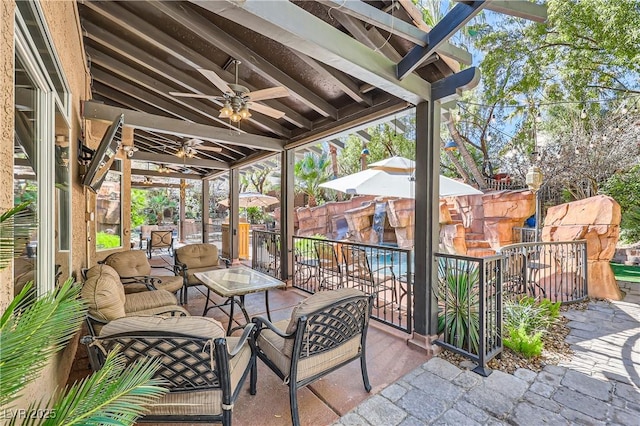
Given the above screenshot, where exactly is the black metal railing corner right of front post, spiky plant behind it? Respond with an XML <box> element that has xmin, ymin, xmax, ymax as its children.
<box><xmin>433</xmin><ymin>253</ymin><xmax>503</xmax><ymax>376</ymax></box>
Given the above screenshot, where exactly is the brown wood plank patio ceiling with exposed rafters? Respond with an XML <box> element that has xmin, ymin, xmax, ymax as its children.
<box><xmin>79</xmin><ymin>0</ymin><xmax>453</xmax><ymax>178</ymax></box>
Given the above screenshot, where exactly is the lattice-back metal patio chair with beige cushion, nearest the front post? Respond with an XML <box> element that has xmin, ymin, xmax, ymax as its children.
<box><xmin>251</xmin><ymin>288</ymin><xmax>373</xmax><ymax>426</ymax></box>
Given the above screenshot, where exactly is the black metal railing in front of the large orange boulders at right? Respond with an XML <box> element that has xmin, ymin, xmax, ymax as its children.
<box><xmin>499</xmin><ymin>240</ymin><xmax>588</xmax><ymax>303</ymax></box>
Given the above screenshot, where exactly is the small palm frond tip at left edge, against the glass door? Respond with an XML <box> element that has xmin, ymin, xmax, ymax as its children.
<box><xmin>0</xmin><ymin>201</ymin><xmax>36</xmax><ymax>269</ymax></box>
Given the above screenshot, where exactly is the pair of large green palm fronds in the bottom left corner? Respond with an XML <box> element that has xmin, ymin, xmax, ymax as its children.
<box><xmin>0</xmin><ymin>279</ymin><xmax>167</xmax><ymax>426</ymax></box>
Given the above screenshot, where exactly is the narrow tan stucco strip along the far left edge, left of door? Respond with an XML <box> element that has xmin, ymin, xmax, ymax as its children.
<box><xmin>0</xmin><ymin>1</ymin><xmax>15</xmax><ymax>312</ymax></box>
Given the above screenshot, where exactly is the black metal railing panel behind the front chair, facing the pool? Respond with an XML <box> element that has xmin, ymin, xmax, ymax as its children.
<box><xmin>293</xmin><ymin>237</ymin><xmax>413</xmax><ymax>333</ymax></box>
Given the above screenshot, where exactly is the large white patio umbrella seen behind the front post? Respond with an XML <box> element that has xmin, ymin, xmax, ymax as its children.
<box><xmin>320</xmin><ymin>157</ymin><xmax>482</xmax><ymax>198</ymax></box>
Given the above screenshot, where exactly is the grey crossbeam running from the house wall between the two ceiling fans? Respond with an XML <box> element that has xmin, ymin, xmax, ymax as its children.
<box><xmin>83</xmin><ymin>101</ymin><xmax>285</xmax><ymax>152</ymax></box>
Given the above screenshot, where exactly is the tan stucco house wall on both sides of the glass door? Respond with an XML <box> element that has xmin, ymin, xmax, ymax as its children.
<box><xmin>5</xmin><ymin>0</ymin><xmax>90</xmax><ymax>407</ymax></box>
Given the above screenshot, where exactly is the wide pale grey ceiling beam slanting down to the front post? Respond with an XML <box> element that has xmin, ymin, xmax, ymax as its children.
<box><xmin>190</xmin><ymin>0</ymin><xmax>431</xmax><ymax>105</ymax></box>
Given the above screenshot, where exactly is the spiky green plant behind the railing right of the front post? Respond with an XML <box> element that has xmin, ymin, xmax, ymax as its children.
<box><xmin>435</xmin><ymin>258</ymin><xmax>480</xmax><ymax>354</ymax></box>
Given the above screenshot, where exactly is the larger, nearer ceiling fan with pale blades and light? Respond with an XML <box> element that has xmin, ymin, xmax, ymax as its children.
<box><xmin>169</xmin><ymin>59</ymin><xmax>289</xmax><ymax>123</ymax></box>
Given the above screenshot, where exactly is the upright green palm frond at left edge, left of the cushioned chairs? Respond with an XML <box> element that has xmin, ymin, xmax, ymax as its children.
<box><xmin>0</xmin><ymin>279</ymin><xmax>85</xmax><ymax>406</ymax></box>
